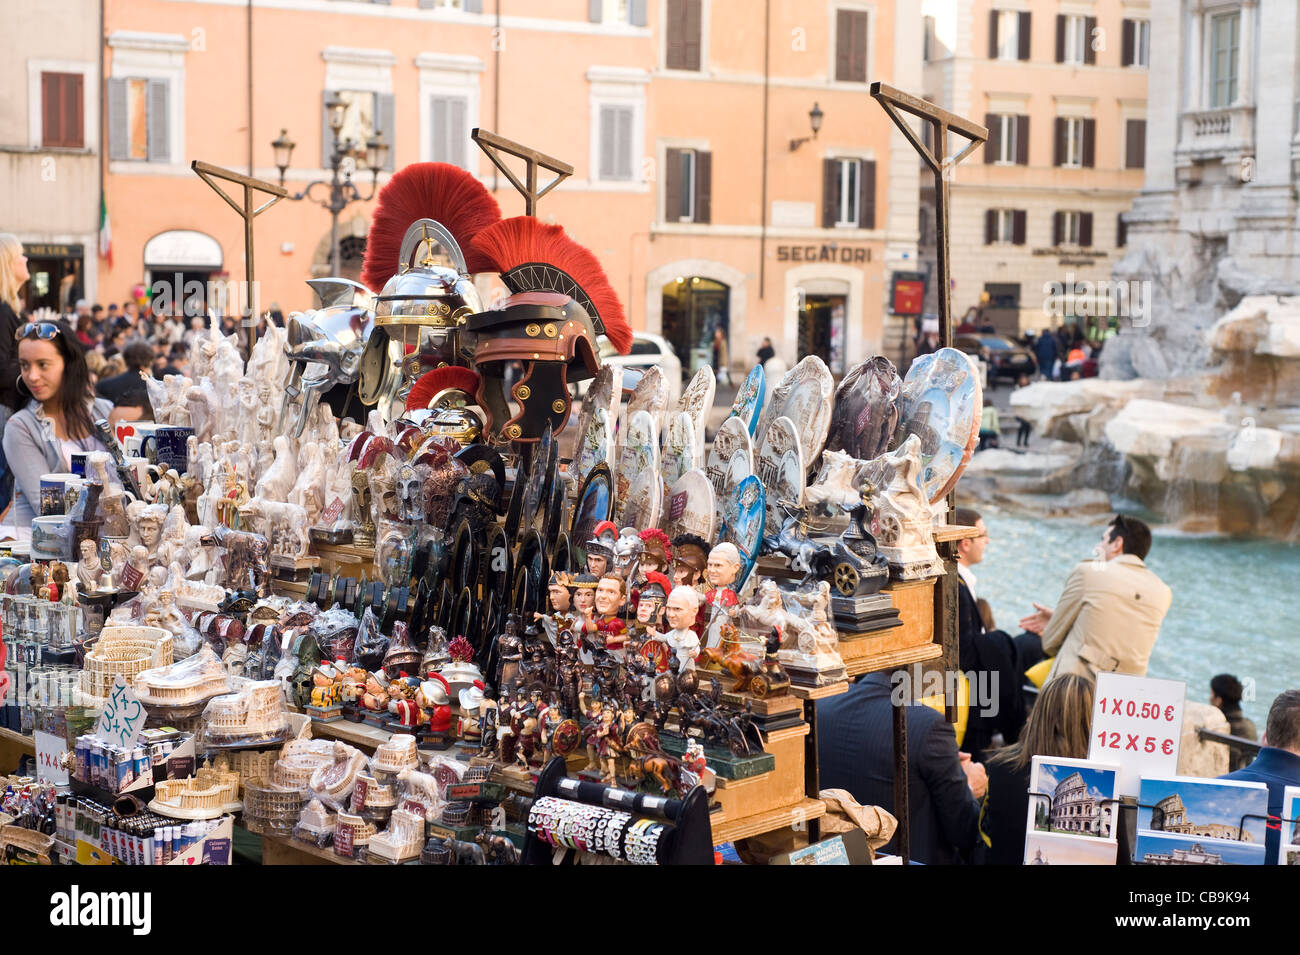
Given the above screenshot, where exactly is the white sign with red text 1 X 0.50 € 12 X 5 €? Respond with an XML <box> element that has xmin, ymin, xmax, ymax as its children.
<box><xmin>1088</xmin><ymin>673</ymin><xmax>1187</xmax><ymax>796</ymax></box>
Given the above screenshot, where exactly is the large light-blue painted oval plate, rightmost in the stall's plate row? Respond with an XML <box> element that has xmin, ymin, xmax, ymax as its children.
<box><xmin>898</xmin><ymin>348</ymin><xmax>984</xmax><ymax>503</ymax></box>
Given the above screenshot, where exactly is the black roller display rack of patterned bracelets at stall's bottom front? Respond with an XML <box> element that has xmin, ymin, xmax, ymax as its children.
<box><xmin>520</xmin><ymin>756</ymin><xmax>714</xmax><ymax>865</ymax></box>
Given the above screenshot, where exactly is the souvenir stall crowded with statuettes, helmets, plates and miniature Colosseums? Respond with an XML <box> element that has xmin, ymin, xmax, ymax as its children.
<box><xmin>0</xmin><ymin>133</ymin><xmax>982</xmax><ymax>864</ymax></box>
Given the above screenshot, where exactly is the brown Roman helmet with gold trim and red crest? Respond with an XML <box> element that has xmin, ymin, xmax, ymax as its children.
<box><xmin>462</xmin><ymin>216</ymin><xmax>632</xmax><ymax>442</ymax></box>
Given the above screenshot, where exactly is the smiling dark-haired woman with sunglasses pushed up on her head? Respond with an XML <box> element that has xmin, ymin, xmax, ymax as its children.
<box><xmin>4</xmin><ymin>322</ymin><xmax>113</xmax><ymax>528</ymax></box>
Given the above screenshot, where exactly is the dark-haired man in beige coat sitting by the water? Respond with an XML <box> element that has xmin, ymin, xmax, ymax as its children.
<box><xmin>1021</xmin><ymin>515</ymin><xmax>1173</xmax><ymax>681</ymax></box>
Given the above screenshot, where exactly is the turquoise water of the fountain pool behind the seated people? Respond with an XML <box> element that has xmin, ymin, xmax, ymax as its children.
<box><xmin>974</xmin><ymin>507</ymin><xmax>1300</xmax><ymax>733</ymax></box>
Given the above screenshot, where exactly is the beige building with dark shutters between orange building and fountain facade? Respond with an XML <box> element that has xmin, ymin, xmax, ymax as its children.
<box><xmin>920</xmin><ymin>0</ymin><xmax>1151</xmax><ymax>334</ymax></box>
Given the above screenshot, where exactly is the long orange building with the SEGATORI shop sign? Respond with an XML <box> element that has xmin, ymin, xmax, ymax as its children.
<box><xmin>98</xmin><ymin>0</ymin><xmax>922</xmax><ymax>372</ymax></box>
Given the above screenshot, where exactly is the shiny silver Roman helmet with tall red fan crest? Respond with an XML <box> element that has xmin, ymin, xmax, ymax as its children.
<box><xmin>359</xmin><ymin>162</ymin><xmax>501</xmax><ymax>421</ymax></box>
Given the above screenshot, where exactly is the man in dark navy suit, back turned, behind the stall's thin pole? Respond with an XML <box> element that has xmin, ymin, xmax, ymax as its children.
<box><xmin>818</xmin><ymin>673</ymin><xmax>987</xmax><ymax>865</ymax></box>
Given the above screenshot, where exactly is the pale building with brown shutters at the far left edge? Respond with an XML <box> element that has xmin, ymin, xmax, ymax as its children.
<box><xmin>0</xmin><ymin>0</ymin><xmax>100</xmax><ymax>311</ymax></box>
